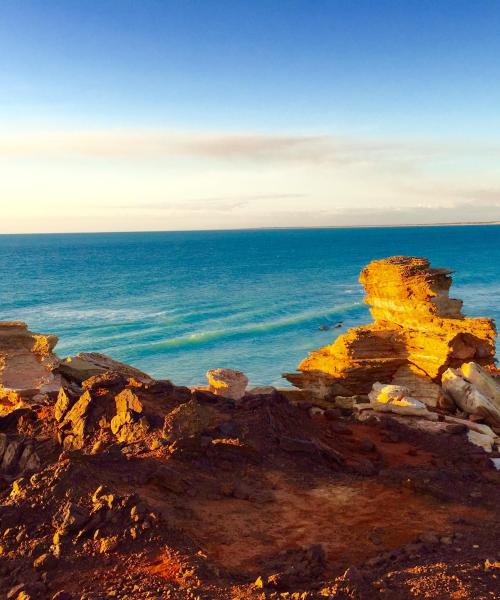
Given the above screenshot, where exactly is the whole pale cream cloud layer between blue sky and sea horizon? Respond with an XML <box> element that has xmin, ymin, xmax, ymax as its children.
<box><xmin>0</xmin><ymin>129</ymin><xmax>500</xmax><ymax>231</ymax></box>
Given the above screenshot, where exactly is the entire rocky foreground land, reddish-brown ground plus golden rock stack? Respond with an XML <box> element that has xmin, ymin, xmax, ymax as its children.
<box><xmin>0</xmin><ymin>257</ymin><xmax>500</xmax><ymax>600</ymax></box>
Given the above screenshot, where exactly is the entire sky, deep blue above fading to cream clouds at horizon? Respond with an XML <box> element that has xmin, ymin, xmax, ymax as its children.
<box><xmin>0</xmin><ymin>0</ymin><xmax>500</xmax><ymax>233</ymax></box>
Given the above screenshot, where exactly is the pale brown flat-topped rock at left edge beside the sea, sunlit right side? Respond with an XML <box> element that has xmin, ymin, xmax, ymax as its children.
<box><xmin>0</xmin><ymin>321</ymin><xmax>58</xmax><ymax>391</ymax></box>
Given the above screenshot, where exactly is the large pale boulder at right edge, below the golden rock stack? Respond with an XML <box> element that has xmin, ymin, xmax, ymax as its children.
<box><xmin>442</xmin><ymin>363</ymin><xmax>500</xmax><ymax>428</ymax></box>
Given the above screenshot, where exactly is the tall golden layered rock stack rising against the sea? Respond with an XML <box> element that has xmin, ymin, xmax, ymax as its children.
<box><xmin>285</xmin><ymin>256</ymin><xmax>496</xmax><ymax>406</ymax></box>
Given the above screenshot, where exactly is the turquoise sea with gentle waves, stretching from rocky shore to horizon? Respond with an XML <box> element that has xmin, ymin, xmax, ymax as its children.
<box><xmin>0</xmin><ymin>226</ymin><xmax>500</xmax><ymax>385</ymax></box>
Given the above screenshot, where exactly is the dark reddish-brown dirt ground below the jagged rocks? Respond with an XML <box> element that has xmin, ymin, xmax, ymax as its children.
<box><xmin>0</xmin><ymin>386</ymin><xmax>500</xmax><ymax>600</ymax></box>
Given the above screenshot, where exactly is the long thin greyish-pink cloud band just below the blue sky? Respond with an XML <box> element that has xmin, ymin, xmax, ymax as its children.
<box><xmin>0</xmin><ymin>129</ymin><xmax>500</xmax><ymax>168</ymax></box>
